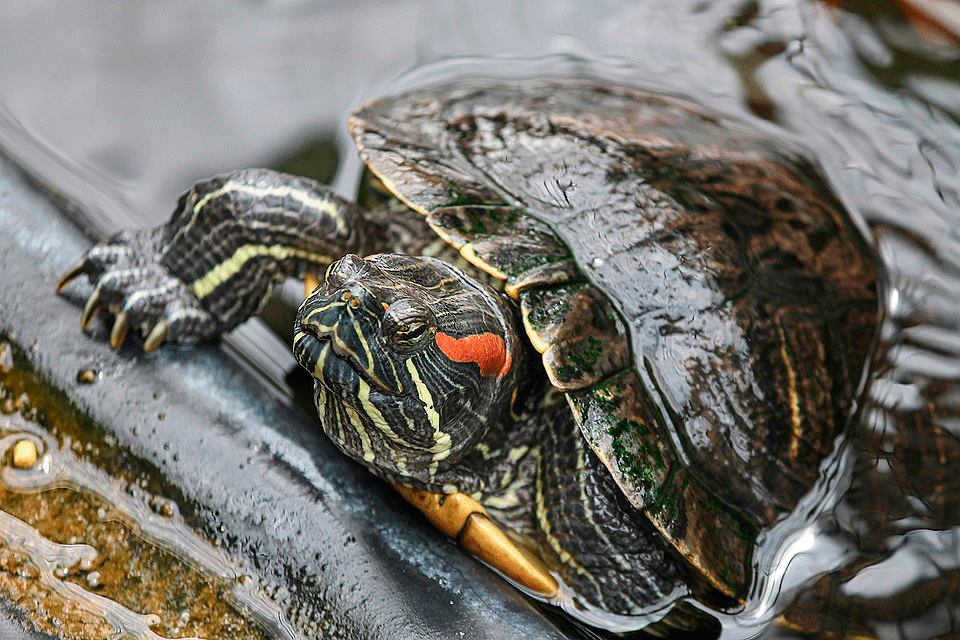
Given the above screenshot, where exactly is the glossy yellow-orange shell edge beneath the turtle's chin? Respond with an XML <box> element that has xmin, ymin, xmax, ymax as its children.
<box><xmin>393</xmin><ymin>485</ymin><xmax>559</xmax><ymax>598</ymax></box>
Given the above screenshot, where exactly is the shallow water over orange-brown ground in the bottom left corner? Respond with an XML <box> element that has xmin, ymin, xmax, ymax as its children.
<box><xmin>0</xmin><ymin>352</ymin><xmax>284</xmax><ymax>640</ymax></box>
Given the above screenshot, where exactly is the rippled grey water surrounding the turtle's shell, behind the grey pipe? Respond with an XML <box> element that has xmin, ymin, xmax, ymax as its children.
<box><xmin>0</xmin><ymin>0</ymin><xmax>960</xmax><ymax>637</ymax></box>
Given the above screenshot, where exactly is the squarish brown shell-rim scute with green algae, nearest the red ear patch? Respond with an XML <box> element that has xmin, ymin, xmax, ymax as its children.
<box><xmin>520</xmin><ymin>284</ymin><xmax>631</xmax><ymax>391</ymax></box>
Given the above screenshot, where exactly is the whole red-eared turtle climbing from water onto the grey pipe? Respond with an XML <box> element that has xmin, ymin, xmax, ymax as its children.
<box><xmin>52</xmin><ymin>79</ymin><xmax>877</xmax><ymax>624</ymax></box>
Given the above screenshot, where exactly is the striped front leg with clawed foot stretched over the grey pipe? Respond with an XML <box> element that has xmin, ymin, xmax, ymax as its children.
<box><xmin>57</xmin><ymin>169</ymin><xmax>366</xmax><ymax>351</ymax></box>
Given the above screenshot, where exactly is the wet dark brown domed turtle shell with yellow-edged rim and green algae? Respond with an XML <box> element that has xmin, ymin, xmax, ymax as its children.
<box><xmin>351</xmin><ymin>79</ymin><xmax>877</xmax><ymax>597</ymax></box>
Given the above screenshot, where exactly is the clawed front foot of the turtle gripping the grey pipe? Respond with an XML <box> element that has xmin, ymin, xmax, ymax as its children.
<box><xmin>56</xmin><ymin>231</ymin><xmax>221</xmax><ymax>352</ymax></box>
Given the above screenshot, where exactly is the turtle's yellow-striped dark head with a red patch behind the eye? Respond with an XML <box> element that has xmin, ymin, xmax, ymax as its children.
<box><xmin>294</xmin><ymin>254</ymin><xmax>521</xmax><ymax>492</ymax></box>
